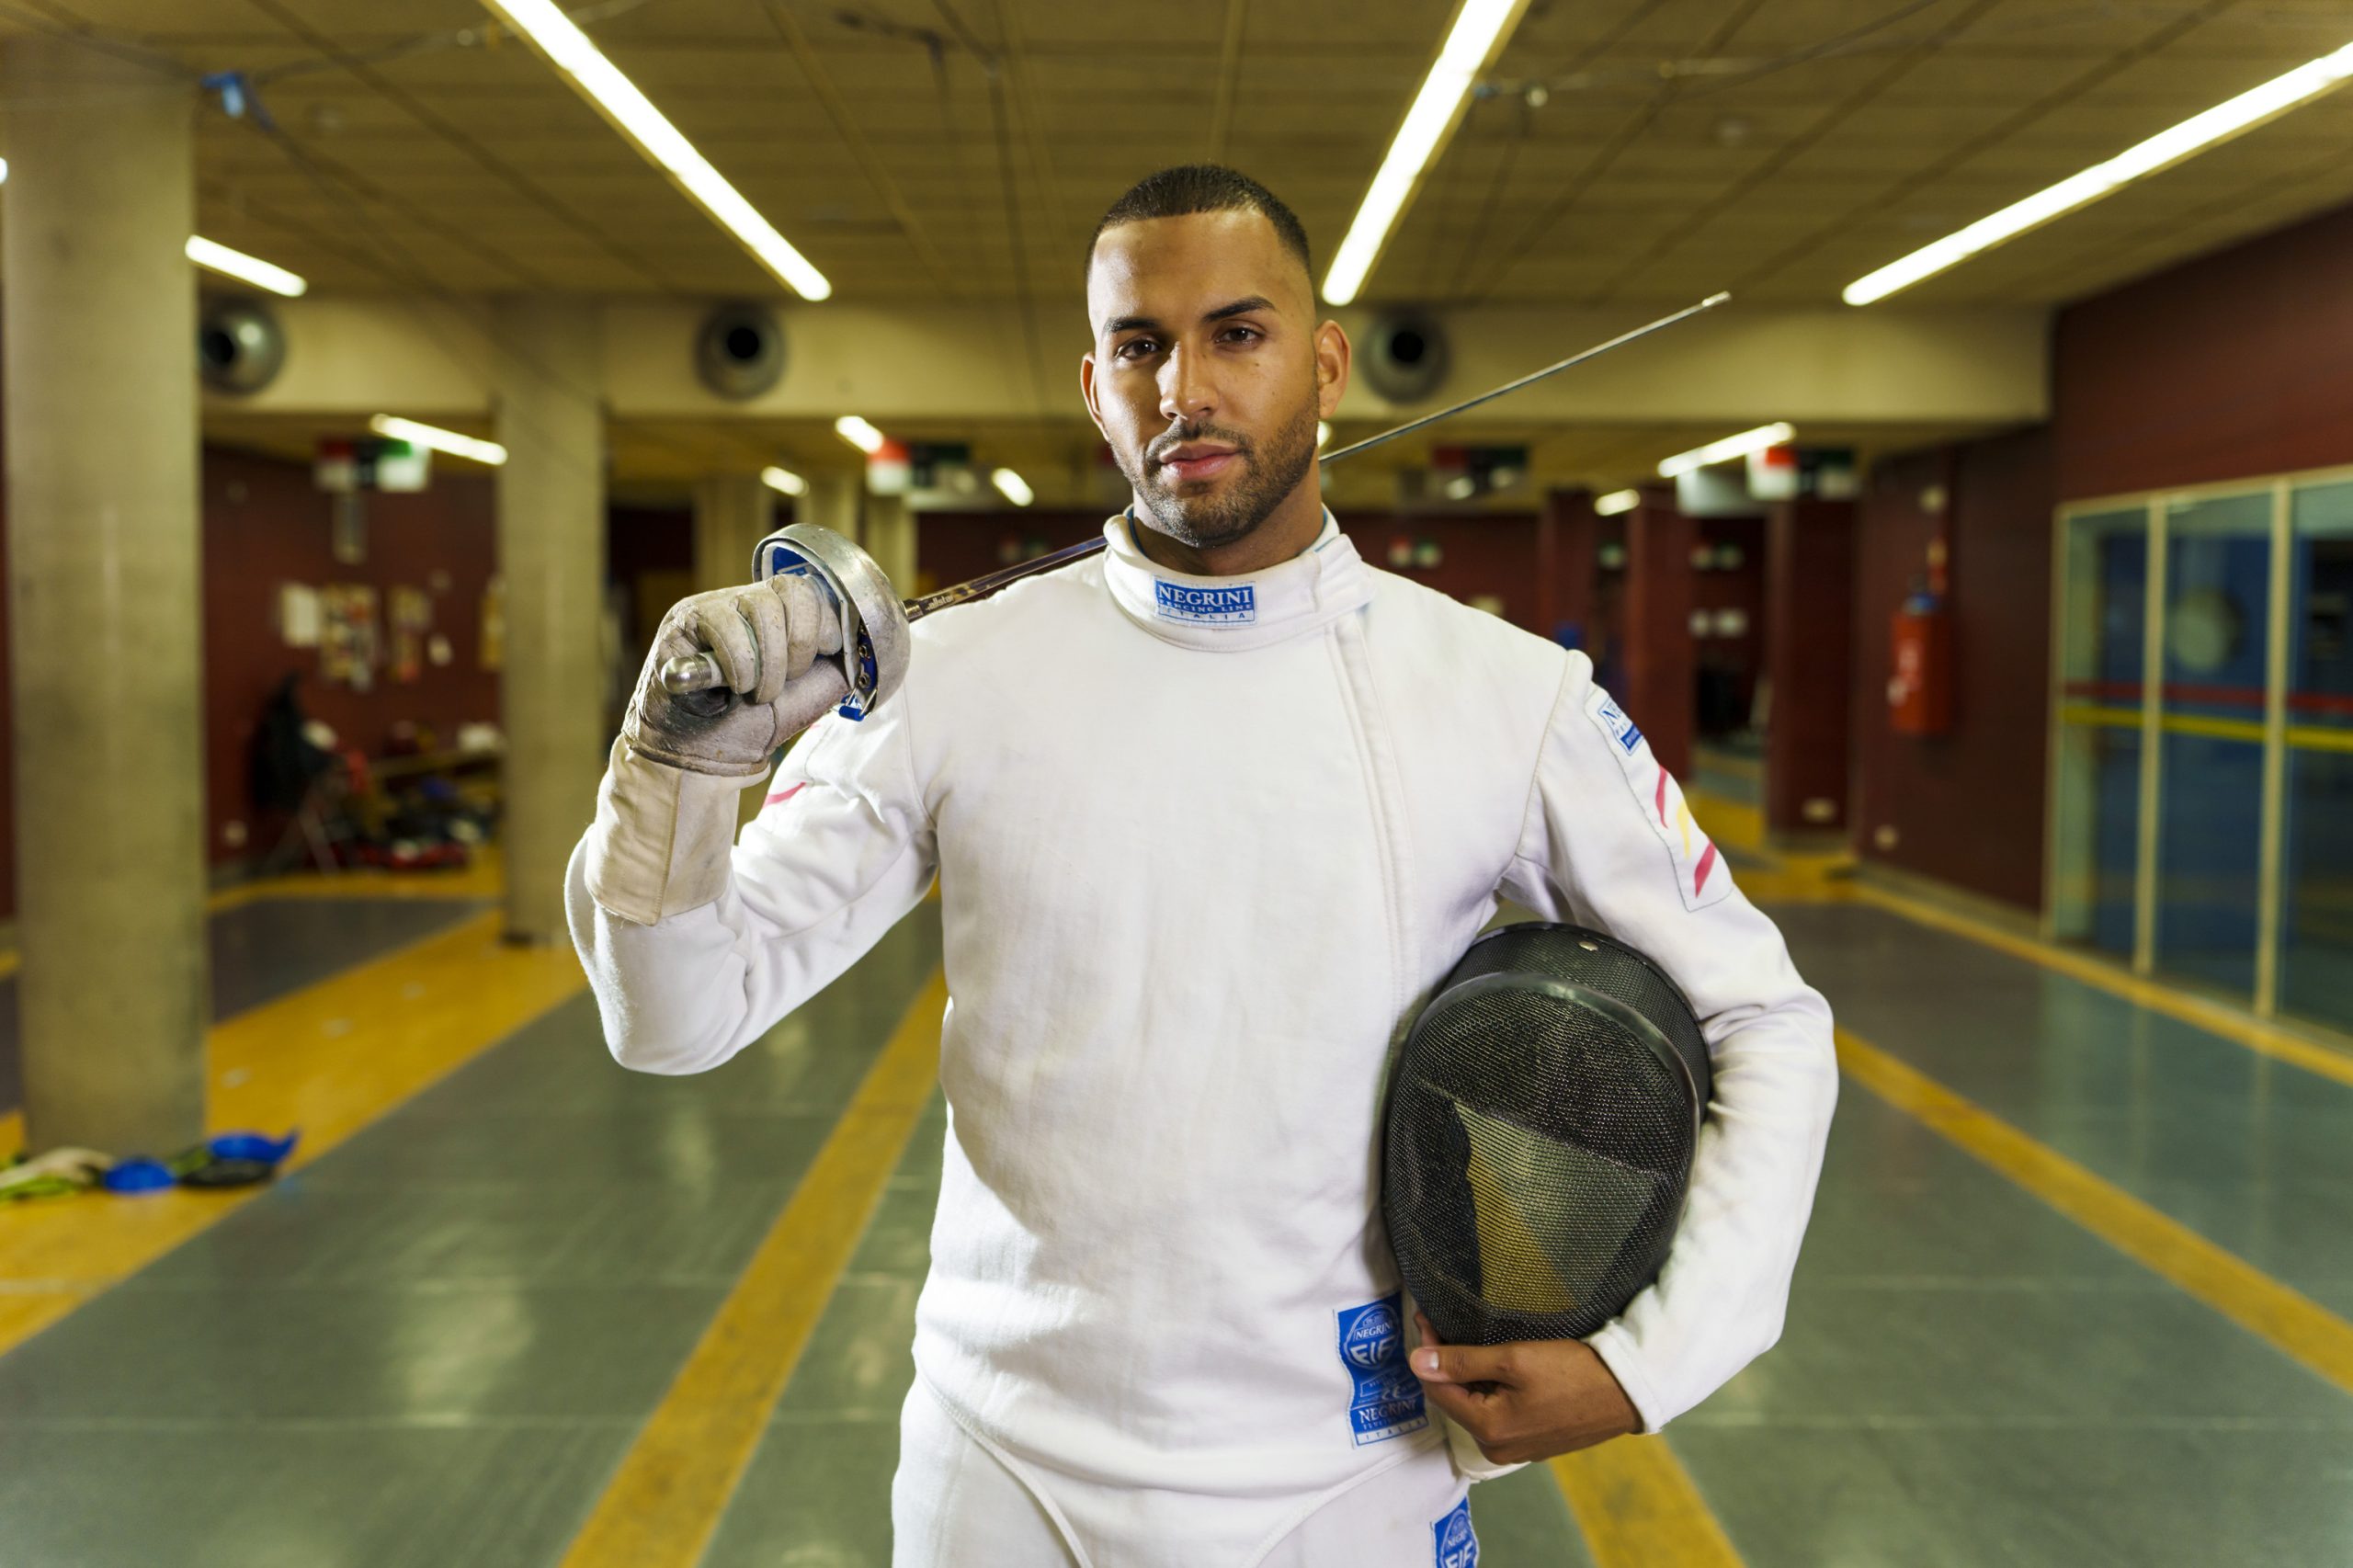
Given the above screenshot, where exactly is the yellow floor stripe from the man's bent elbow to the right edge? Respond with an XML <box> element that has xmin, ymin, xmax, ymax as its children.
<box><xmin>1837</xmin><ymin>1028</ymin><xmax>2353</xmax><ymax>1393</ymax></box>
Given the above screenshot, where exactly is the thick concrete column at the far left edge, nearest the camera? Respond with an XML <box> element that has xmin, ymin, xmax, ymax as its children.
<box><xmin>0</xmin><ymin>33</ymin><xmax>210</xmax><ymax>1153</ymax></box>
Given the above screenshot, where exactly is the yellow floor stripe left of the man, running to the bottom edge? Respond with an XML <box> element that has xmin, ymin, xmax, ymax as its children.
<box><xmin>563</xmin><ymin>972</ymin><xmax>949</xmax><ymax>1568</ymax></box>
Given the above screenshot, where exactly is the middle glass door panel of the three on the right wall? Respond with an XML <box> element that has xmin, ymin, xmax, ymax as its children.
<box><xmin>2155</xmin><ymin>487</ymin><xmax>2270</xmax><ymax>996</ymax></box>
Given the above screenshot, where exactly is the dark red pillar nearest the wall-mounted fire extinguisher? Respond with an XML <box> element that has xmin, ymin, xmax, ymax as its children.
<box><xmin>1765</xmin><ymin>496</ymin><xmax>1854</xmax><ymax>834</ymax></box>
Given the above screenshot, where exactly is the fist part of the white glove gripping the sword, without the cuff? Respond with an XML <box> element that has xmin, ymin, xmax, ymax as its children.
<box><xmin>621</xmin><ymin>577</ymin><xmax>849</xmax><ymax>777</ymax></box>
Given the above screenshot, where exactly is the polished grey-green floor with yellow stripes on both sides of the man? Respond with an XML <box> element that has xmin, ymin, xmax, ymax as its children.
<box><xmin>0</xmin><ymin>828</ymin><xmax>2353</xmax><ymax>1568</ymax></box>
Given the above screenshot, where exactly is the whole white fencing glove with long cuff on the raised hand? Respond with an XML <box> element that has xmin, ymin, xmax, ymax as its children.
<box><xmin>585</xmin><ymin>577</ymin><xmax>849</xmax><ymax>926</ymax></box>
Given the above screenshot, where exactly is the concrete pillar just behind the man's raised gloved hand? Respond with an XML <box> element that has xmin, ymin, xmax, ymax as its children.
<box><xmin>492</xmin><ymin>299</ymin><xmax>612</xmax><ymax>942</ymax></box>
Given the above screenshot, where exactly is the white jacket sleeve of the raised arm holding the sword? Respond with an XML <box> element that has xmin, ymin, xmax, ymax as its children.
<box><xmin>564</xmin><ymin>706</ymin><xmax>937</xmax><ymax>1074</ymax></box>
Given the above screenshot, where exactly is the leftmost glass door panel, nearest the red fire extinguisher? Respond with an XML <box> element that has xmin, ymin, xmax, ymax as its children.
<box><xmin>2052</xmin><ymin>506</ymin><xmax>2148</xmax><ymax>959</ymax></box>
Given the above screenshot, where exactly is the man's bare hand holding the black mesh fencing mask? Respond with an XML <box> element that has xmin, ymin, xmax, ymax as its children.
<box><xmin>1412</xmin><ymin>1312</ymin><xmax>1643</xmax><ymax>1464</ymax></box>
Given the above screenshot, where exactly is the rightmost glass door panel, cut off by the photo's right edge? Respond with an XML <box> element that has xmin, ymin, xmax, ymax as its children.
<box><xmin>2280</xmin><ymin>483</ymin><xmax>2353</xmax><ymax>1028</ymax></box>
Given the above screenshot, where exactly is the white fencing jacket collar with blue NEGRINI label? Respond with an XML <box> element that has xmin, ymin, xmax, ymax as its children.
<box><xmin>1104</xmin><ymin>508</ymin><xmax>1371</xmax><ymax>653</ymax></box>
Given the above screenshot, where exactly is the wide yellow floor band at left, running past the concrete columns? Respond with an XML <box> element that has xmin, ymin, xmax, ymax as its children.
<box><xmin>0</xmin><ymin>911</ymin><xmax>585</xmax><ymax>1351</ymax></box>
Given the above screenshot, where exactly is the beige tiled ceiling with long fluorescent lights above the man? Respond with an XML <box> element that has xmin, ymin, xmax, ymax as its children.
<box><xmin>18</xmin><ymin>0</ymin><xmax>2353</xmax><ymax>489</ymax></box>
